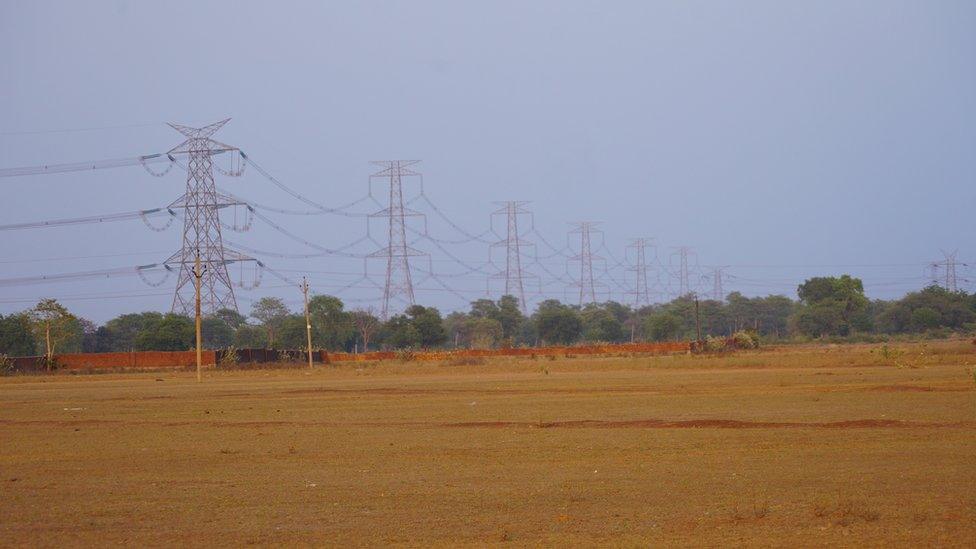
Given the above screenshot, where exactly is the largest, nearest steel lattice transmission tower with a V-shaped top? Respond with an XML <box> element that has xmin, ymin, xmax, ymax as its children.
<box><xmin>165</xmin><ymin>118</ymin><xmax>253</xmax><ymax>314</ymax></box>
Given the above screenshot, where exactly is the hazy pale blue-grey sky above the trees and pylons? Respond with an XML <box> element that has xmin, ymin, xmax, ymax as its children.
<box><xmin>0</xmin><ymin>0</ymin><xmax>976</xmax><ymax>322</ymax></box>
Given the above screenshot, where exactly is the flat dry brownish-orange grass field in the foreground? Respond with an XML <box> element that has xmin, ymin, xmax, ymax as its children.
<box><xmin>0</xmin><ymin>342</ymin><xmax>976</xmax><ymax>547</ymax></box>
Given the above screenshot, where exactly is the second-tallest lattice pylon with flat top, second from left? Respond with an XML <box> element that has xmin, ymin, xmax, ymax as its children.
<box><xmin>368</xmin><ymin>160</ymin><xmax>427</xmax><ymax>320</ymax></box>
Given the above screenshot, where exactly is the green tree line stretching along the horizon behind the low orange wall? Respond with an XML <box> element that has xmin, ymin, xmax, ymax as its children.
<box><xmin>0</xmin><ymin>275</ymin><xmax>976</xmax><ymax>356</ymax></box>
